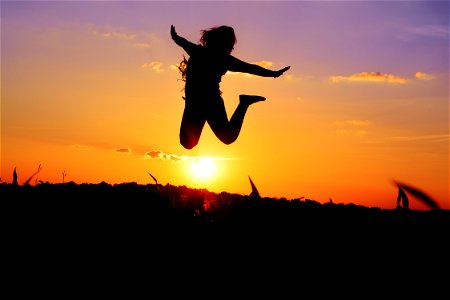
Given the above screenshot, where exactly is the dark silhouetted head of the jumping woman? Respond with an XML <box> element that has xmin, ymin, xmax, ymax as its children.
<box><xmin>200</xmin><ymin>26</ymin><xmax>237</xmax><ymax>54</ymax></box>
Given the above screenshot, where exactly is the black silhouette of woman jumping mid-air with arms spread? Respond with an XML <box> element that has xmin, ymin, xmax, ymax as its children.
<box><xmin>170</xmin><ymin>25</ymin><xmax>290</xmax><ymax>149</ymax></box>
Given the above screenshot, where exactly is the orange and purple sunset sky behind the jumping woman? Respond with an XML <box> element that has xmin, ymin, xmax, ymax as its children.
<box><xmin>0</xmin><ymin>1</ymin><xmax>450</xmax><ymax>209</ymax></box>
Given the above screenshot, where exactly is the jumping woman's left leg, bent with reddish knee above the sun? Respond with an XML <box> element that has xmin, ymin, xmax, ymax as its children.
<box><xmin>180</xmin><ymin>105</ymin><xmax>206</xmax><ymax>149</ymax></box>
